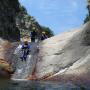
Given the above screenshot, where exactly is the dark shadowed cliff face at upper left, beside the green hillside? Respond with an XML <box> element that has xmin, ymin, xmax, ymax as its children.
<box><xmin>0</xmin><ymin>0</ymin><xmax>20</xmax><ymax>41</ymax></box>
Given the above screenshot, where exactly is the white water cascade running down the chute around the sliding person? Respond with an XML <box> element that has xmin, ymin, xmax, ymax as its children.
<box><xmin>12</xmin><ymin>43</ymin><xmax>38</xmax><ymax>80</ymax></box>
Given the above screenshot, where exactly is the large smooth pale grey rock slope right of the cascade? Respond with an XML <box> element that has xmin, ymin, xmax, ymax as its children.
<box><xmin>36</xmin><ymin>23</ymin><xmax>90</xmax><ymax>83</ymax></box>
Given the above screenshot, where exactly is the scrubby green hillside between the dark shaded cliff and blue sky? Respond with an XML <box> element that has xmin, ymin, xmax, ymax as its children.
<box><xmin>16</xmin><ymin>6</ymin><xmax>54</xmax><ymax>37</ymax></box>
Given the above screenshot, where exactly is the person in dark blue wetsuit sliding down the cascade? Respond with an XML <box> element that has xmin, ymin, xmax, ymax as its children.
<box><xmin>20</xmin><ymin>41</ymin><xmax>30</xmax><ymax>61</ymax></box>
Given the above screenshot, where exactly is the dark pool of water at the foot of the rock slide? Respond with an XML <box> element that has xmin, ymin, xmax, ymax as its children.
<box><xmin>0</xmin><ymin>81</ymin><xmax>89</xmax><ymax>90</ymax></box>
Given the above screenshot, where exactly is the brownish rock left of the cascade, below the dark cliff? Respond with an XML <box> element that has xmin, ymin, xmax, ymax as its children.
<box><xmin>0</xmin><ymin>39</ymin><xmax>17</xmax><ymax>78</ymax></box>
